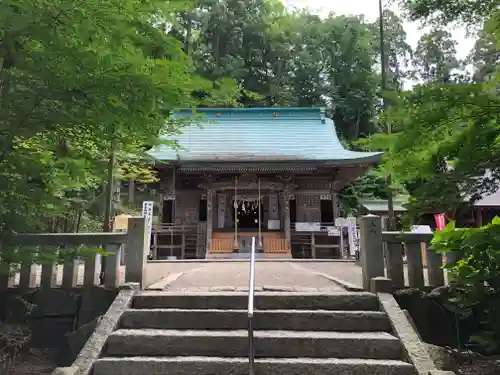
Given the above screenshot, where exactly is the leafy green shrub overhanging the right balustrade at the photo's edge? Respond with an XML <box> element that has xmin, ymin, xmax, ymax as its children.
<box><xmin>431</xmin><ymin>217</ymin><xmax>500</xmax><ymax>351</ymax></box>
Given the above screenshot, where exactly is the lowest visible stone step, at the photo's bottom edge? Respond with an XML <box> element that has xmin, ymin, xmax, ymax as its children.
<box><xmin>94</xmin><ymin>357</ymin><xmax>417</xmax><ymax>375</ymax></box>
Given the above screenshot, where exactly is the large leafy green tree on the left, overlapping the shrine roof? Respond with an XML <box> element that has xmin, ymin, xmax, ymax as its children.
<box><xmin>0</xmin><ymin>0</ymin><xmax>231</xmax><ymax>234</ymax></box>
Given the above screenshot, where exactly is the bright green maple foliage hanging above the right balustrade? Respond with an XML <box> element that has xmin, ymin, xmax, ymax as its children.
<box><xmin>371</xmin><ymin>80</ymin><xmax>500</xmax><ymax>218</ymax></box>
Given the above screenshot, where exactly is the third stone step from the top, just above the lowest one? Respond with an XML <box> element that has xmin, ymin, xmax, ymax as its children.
<box><xmin>106</xmin><ymin>329</ymin><xmax>403</xmax><ymax>359</ymax></box>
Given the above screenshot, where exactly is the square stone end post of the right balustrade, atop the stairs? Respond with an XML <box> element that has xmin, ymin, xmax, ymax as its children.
<box><xmin>359</xmin><ymin>215</ymin><xmax>385</xmax><ymax>290</ymax></box>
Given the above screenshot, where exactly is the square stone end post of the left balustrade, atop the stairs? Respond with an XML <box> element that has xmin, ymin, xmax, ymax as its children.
<box><xmin>125</xmin><ymin>217</ymin><xmax>149</xmax><ymax>289</ymax></box>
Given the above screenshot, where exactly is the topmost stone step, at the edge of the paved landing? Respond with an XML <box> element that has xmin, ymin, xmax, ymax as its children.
<box><xmin>133</xmin><ymin>291</ymin><xmax>379</xmax><ymax>311</ymax></box>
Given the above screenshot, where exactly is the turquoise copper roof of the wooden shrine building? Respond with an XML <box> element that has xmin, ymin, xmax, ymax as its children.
<box><xmin>149</xmin><ymin>108</ymin><xmax>381</xmax><ymax>164</ymax></box>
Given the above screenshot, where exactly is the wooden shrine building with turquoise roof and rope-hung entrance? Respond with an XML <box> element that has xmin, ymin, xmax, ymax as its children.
<box><xmin>131</xmin><ymin>108</ymin><xmax>381</xmax><ymax>259</ymax></box>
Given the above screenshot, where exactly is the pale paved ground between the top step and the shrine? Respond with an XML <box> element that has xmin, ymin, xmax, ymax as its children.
<box><xmin>148</xmin><ymin>261</ymin><xmax>364</xmax><ymax>292</ymax></box>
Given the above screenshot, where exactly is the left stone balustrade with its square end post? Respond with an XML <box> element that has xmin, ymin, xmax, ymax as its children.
<box><xmin>0</xmin><ymin>217</ymin><xmax>149</xmax><ymax>290</ymax></box>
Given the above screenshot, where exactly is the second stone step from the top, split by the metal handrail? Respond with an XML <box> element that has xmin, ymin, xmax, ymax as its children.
<box><xmin>120</xmin><ymin>309</ymin><xmax>391</xmax><ymax>332</ymax></box>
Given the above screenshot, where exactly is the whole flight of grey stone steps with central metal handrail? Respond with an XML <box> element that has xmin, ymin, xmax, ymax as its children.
<box><xmin>93</xmin><ymin>291</ymin><xmax>417</xmax><ymax>375</ymax></box>
